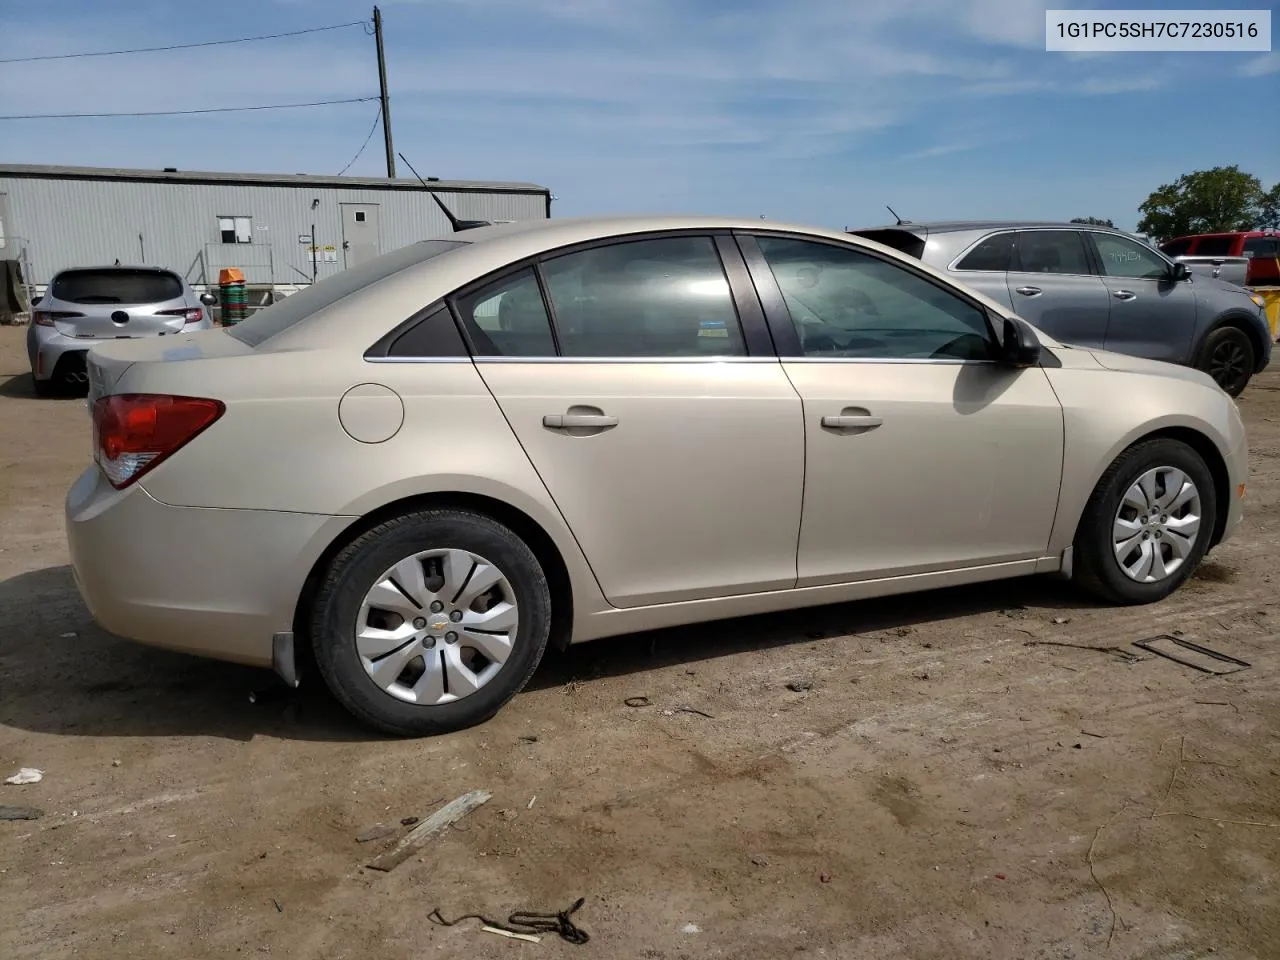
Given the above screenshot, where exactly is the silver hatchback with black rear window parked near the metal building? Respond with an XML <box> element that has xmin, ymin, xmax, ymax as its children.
<box><xmin>27</xmin><ymin>266</ymin><xmax>214</xmax><ymax>396</ymax></box>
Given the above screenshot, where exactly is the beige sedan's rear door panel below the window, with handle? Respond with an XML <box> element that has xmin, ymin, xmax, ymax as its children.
<box><xmin>476</xmin><ymin>360</ymin><xmax>804</xmax><ymax>607</ymax></box>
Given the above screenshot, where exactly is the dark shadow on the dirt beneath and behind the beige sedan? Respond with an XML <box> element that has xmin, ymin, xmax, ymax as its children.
<box><xmin>0</xmin><ymin>566</ymin><xmax>1093</xmax><ymax>742</ymax></box>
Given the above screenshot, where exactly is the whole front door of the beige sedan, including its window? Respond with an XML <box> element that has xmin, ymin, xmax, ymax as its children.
<box><xmin>744</xmin><ymin>236</ymin><xmax>1062</xmax><ymax>586</ymax></box>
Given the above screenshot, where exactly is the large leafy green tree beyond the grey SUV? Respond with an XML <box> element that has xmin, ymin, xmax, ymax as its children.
<box><xmin>1138</xmin><ymin>164</ymin><xmax>1270</xmax><ymax>241</ymax></box>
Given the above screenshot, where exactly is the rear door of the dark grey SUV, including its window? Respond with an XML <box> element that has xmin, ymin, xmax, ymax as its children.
<box><xmin>1006</xmin><ymin>229</ymin><xmax>1111</xmax><ymax>347</ymax></box>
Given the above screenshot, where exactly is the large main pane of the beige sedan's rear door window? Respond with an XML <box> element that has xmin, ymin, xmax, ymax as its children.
<box><xmin>541</xmin><ymin>237</ymin><xmax>746</xmax><ymax>358</ymax></box>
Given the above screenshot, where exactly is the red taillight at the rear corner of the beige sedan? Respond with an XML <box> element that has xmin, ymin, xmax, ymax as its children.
<box><xmin>93</xmin><ymin>393</ymin><xmax>227</xmax><ymax>490</ymax></box>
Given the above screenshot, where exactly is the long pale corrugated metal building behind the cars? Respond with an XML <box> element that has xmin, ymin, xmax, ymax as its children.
<box><xmin>0</xmin><ymin>164</ymin><xmax>552</xmax><ymax>289</ymax></box>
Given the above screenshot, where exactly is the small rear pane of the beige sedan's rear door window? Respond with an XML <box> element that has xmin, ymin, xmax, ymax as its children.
<box><xmin>457</xmin><ymin>268</ymin><xmax>556</xmax><ymax>357</ymax></box>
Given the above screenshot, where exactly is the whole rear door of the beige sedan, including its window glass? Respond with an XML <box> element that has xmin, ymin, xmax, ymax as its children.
<box><xmin>456</xmin><ymin>236</ymin><xmax>804</xmax><ymax>607</ymax></box>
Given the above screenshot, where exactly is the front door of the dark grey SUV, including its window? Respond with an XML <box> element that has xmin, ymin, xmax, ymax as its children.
<box><xmin>1088</xmin><ymin>233</ymin><xmax>1197</xmax><ymax>364</ymax></box>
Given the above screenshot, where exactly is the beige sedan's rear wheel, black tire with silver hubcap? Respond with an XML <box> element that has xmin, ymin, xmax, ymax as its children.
<box><xmin>311</xmin><ymin>509</ymin><xmax>550</xmax><ymax>736</ymax></box>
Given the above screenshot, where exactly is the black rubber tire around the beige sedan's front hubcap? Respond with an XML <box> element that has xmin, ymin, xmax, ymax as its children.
<box><xmin>1073</xmin><ymin>439</ymin><xmax>1217</xmax><ymax>605</ymax></box>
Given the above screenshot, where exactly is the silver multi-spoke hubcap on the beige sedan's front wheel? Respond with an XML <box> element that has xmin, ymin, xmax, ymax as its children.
<box><xmin>1111</xmin><ymin>467</ymin><xmax>1201</xmax><ymax>584</ymax></box>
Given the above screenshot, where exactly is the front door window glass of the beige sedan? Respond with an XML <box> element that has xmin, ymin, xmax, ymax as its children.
<box><xmin>756</xmin><ymin>237</ymin><xmax>991</xmax><ymax>360</ymax></box>
